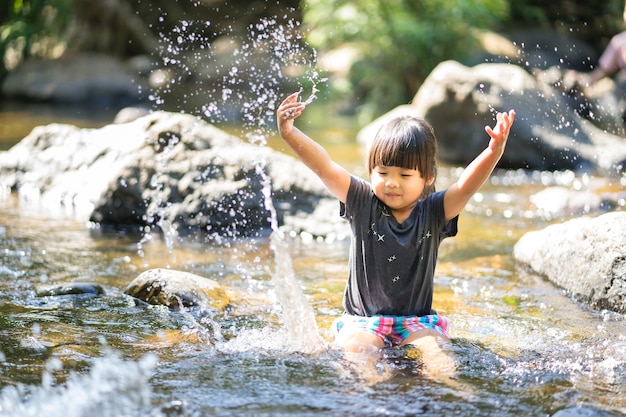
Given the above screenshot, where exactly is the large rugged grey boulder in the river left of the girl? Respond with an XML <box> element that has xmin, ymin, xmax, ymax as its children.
<box><xmin>0</xmin><ymin>112</ymin><xmax>343</xmax><ymax>238</ymax></box>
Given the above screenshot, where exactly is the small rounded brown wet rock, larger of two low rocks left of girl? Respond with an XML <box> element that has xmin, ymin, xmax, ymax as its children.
<box><xmin>124</xmin><ymin>268</ymin><xmax>231</xmax><ymax>311</ymax></box>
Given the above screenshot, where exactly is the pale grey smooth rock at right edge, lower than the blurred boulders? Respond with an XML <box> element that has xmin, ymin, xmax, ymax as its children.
<box><xmin>513</xmin><ymin>212</ymin><xmax>626</xmax><ymax>313</ymax></box>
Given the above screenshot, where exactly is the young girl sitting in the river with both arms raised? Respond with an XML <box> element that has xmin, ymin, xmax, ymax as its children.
<box><xmin>276</xmin><ymin>93</ymin><xmax>515</xmax><ymax>365</ymax></box>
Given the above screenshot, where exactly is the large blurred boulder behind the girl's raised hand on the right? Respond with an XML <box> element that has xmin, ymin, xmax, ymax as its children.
<box><xmin>358</xmin><ymin>61</ymin><xmax>626</xmax><ymax>173</ymax></box>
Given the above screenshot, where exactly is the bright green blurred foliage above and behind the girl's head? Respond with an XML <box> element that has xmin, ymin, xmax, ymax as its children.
<box><xmin>303</xmin><ymin>0</ymin><xmax>509</xmax><ymax>119</ymax></box>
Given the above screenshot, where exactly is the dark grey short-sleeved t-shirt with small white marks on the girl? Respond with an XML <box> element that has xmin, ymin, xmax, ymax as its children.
<box><xmin>341</xmin><ymin>176</ymin><xmax>458</xmax><ymax>316</ymax></box>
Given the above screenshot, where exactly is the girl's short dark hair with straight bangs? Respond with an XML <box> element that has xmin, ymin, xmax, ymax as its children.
<box><xmin>368</xmin><ymin>117</ymin><xmax>437</xmax><ymax>178</ymax></box>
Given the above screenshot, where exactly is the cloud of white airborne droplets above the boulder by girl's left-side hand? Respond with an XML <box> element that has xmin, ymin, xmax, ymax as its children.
<box><xmin>150</xmin><ymin>17</ymin><xmax>327</xmax><ymax>132</ymax></box>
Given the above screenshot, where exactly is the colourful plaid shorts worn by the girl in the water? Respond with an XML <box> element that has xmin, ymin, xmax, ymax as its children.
<box><xmin>332</xmin><ymin>314</ymin><xmax>450</xmax><ymax>346</ymax></box>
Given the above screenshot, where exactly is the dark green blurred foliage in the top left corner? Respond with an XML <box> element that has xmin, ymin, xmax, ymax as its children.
<box><xmin>0</xmin><ymin>0</ymin><xmax>71</xmax><ymax>76</ymax></box>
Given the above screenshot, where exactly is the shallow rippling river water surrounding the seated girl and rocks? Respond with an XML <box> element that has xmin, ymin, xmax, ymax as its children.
<box><xmin>0</xmin><ymin>101</ymin><xmax>626</xmax><ymax>417</ymax></box>
